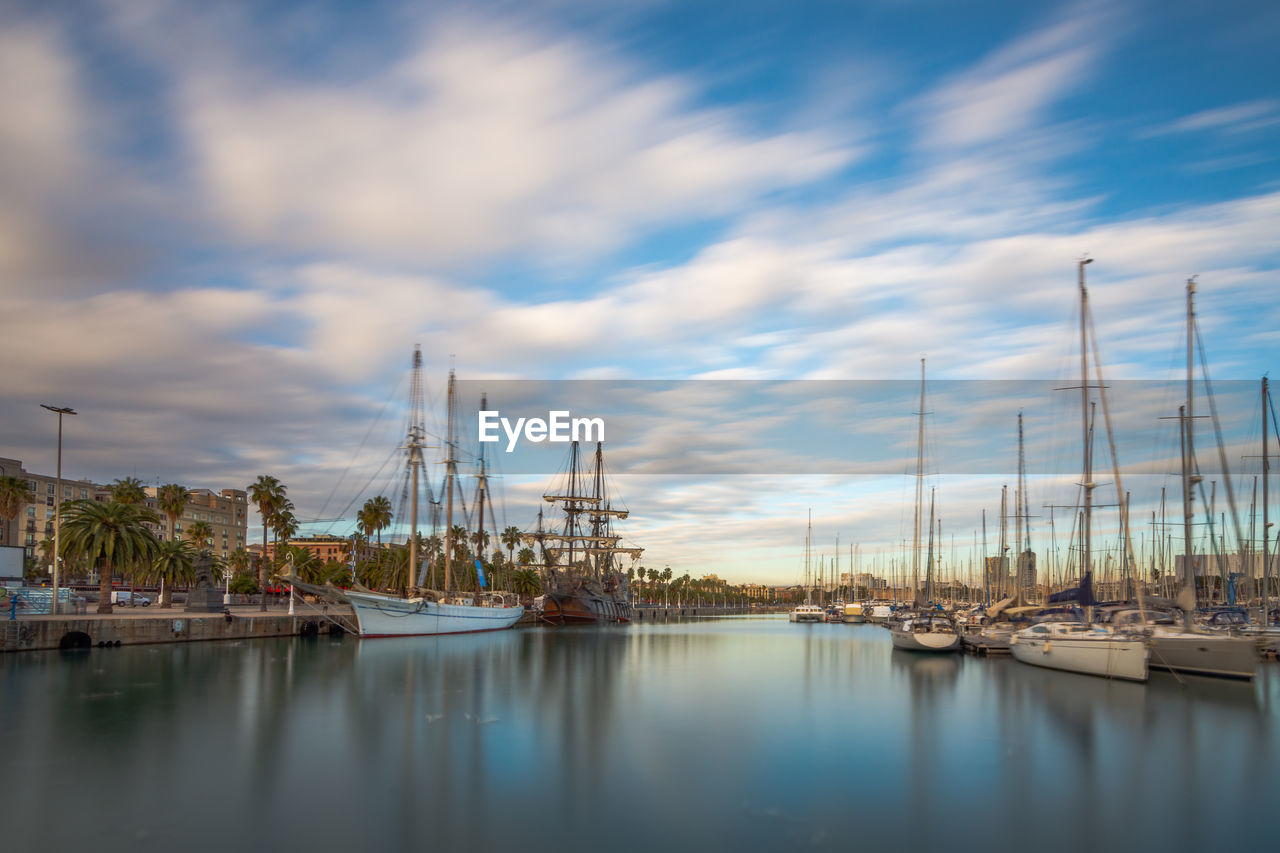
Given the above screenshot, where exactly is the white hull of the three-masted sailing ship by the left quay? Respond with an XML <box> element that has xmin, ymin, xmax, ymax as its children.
<box><xmin>343</xmin><ymin>590</ymin><xmax>525</xmax><ymax>637</ymax></box>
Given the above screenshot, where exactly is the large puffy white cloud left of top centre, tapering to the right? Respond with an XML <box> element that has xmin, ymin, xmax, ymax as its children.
<box><xmin>170</xmin><ymin>24</ymin><xmax>854</xmax><ymax>263</ymax></box>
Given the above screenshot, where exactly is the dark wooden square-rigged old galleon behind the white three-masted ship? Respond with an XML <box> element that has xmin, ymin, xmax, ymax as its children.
<box><xmin>524</xmin><ymin>441</ymin><xmax>644</xmax><ymax>625</ymax></box>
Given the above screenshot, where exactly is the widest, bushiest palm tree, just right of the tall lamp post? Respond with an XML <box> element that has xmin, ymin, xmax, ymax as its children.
<box><xmin>61</xmin><ymin>501</ymin><xmax>160</xmax><ymax>613</ymax></box>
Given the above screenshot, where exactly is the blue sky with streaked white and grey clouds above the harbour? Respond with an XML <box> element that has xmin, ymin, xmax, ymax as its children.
<box><xmin>0</xmin><ymin>0</ymin><xmax>1280</xmax><ymax>583</ymax></box>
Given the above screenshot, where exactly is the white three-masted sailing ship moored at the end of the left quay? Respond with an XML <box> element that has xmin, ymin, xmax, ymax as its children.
<box><xmin>284</xmin><ymin>347</ymin><xmax>525</xmax><ymax>637</ymax></box>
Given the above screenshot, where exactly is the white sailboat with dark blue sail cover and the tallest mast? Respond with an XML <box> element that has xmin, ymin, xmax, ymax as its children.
<box><xmin>1010</xmin><ymin>259</ymin><xmax>1147</xmax><ymax>681</ymax></box>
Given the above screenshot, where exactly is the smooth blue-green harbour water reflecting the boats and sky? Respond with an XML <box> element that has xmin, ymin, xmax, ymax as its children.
<box><xmin>0</xmin><ymin>617</ymin><xmax>1280</xmax><ymax>853</ymax></box>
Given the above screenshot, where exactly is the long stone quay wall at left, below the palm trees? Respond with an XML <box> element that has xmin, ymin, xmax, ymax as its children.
<box><xmin>0</xmin><ymin>604</ymin><xmax>349</xmax><ymax>652</ymax></box>
